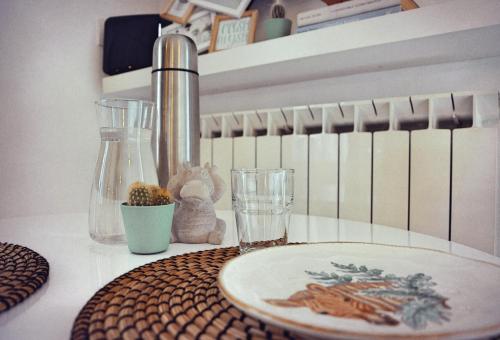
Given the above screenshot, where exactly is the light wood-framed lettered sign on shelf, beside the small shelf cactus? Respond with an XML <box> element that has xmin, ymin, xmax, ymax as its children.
<box><xmin>208</xmin><ymin>10</ymin><xmax>258</xmax><ymax>52</ymax></box>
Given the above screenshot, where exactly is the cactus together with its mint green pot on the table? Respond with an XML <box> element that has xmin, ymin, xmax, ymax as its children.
<box><xmin>121</xmin><ymin>182</ymin><xmax>175</xmax><ymax>254</ymax></box>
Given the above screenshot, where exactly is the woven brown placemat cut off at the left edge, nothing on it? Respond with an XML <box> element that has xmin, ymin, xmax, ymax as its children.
<box><xmin>0</xmin><ymin>242</ymin><xmax>49</xmax><ymax>313</ymax></box>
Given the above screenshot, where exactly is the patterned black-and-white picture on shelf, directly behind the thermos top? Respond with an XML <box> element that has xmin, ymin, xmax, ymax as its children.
<box><xmin>161</xmin><ymin>11</ymin><xmax>215</xmax><ymax>53</ymax></box>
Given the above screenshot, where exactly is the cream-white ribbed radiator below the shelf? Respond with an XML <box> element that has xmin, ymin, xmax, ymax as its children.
<box><xmin>201</xmin><ymin>92</ymin><xmax>500</xmax><ymax>255</ymax></box>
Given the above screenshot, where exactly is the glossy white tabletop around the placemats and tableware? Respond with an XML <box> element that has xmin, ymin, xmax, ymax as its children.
<box><xmin>0</xmin><ymin>211</ymin><xmax>500</xmax><ymax>339</ymax></box>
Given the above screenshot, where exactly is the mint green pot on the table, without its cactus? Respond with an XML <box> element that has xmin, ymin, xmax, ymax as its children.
<box><xmin>121</xmin><ymin>203</ymin><xmax>175</xmax><ymax>254</ymax></box>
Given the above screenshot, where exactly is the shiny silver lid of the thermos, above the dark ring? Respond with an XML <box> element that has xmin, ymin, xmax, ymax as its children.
<box><xmin>153</xmin><ymin>34</ymin><xmax>198</xmax><ymax>74</ymax></box>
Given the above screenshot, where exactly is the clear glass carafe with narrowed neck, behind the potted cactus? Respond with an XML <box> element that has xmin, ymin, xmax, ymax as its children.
<box><xmin>89</xmin><ymin>99</ymin><xmax>158</xmax><ymax>243</ymax></box>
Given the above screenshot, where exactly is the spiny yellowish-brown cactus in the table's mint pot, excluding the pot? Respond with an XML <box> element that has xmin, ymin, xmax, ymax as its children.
<box><xmin>127</xmin><ymin>182</ymin><xmax>172</xmax><ymax>206</ymax></box>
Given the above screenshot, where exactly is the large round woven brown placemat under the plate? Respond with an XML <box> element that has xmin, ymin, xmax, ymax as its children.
<box><xmin>71</xmin><ymin>247</ymin><xmax>294</xmax><ymax>339</ymax></box>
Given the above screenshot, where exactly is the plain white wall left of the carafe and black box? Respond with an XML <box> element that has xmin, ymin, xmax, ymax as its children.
<box><xmin>0</xmin><ymin>0</ymin><xmax>160</xmax><ymax>218</ymax></box>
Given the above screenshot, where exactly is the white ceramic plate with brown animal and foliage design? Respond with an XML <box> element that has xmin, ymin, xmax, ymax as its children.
<box><xmin>219</xmin><ymin>243</ymin><xmax>500</xmax><ymax>339</ymax></box>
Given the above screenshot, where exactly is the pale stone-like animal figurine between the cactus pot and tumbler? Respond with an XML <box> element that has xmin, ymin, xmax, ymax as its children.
<box><xmin>167</xmin><ymin>163</ymin><xmax>226</xmax><ymax>244</ymax></box>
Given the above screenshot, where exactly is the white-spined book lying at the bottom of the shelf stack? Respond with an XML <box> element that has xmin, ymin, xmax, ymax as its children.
<box><xmin>297</xmin><ymin>0</ymin><xmax>400</xmax><ymax>27</ymax></box>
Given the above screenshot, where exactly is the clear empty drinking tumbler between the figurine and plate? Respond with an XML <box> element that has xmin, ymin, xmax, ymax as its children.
<box><xmin>231</xmin><ymin>169</ymin><xmax>294</xmax><ymax>254</ymax></box>
